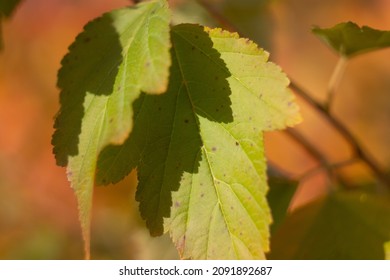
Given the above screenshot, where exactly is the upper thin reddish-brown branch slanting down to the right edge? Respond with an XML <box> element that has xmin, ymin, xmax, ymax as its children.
<box><xmin>290</xmin><ymin>82</ymin><xmax>390</xmax><ymax>188</ymax></box>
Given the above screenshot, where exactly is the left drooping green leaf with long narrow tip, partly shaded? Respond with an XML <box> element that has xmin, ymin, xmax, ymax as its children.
<box><xmin>52</xmin><ymin>1</ymin><xmax>170</xmax><ymax>258</ymax></box>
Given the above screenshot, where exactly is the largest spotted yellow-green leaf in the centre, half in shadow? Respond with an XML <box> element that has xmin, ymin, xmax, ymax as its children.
<box><xmin>97</xmin><ymin>24</ymin><xmax>300</xmax><ymax>259</ymax></box>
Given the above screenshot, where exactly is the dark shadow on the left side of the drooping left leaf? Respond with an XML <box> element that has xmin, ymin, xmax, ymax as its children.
<box><xmin>52</xmin><ymin>7</ymin><xmax>136</xmax><ymax>166</ymax></box>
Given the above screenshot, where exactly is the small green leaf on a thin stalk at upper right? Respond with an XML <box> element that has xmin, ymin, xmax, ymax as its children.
<box><xmin>312</xmin><ymin>22</ymin><xmax>390</xmax><ymax>57</ymax></box>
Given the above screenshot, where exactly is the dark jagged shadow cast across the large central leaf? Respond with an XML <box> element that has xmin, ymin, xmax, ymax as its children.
<box><xmin>96</xmin><ymin>24</ymin><xmax>233</xmax><ymax>236</ymax></box>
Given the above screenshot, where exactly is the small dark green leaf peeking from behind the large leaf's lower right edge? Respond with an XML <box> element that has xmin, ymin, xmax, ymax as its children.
<box><xmin>267</xmin><ymin>175</ymin><xmax>298</xmax><ymax>234</ymax></box>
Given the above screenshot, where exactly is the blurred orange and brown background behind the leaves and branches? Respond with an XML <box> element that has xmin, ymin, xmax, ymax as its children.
<box><xmin>0</xmin><ymin>0</ymin><xmax>390</xmax><ymax>259</ymax></box>
